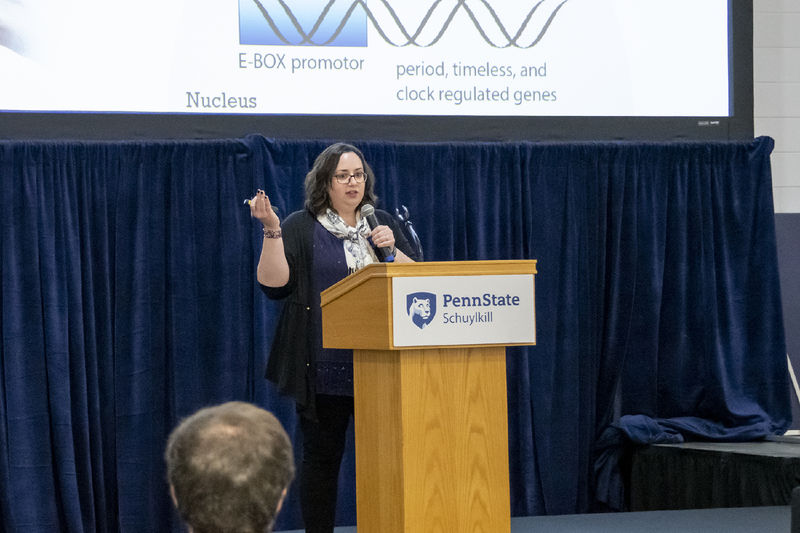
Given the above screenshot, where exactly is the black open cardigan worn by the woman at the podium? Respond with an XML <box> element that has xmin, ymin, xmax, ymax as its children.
<box><xmin>259</xmin><ymin>209</ymin><xmax>416</xmax><ymax>418</ymax></box>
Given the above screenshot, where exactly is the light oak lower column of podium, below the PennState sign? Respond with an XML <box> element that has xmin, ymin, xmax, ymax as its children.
<box><xmin>353</xmin><ymin>346</ymin><xmax>511</xmax><ymax>533</ymax></box>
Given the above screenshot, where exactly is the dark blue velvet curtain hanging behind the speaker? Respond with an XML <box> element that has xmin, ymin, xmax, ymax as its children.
<box><xmin>0</xmin><ymin>136</ymin><xmax>791</xmax><ymax>532</ymax></box>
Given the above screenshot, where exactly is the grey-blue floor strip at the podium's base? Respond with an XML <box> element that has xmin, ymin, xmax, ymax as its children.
<box><xmin>278</xmin><ymin>505</ymin><xmax>791</xmax><ymax>533</ymax></box>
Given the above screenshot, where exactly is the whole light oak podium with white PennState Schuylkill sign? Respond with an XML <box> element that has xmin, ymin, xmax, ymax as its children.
<box><xmin>321</xmin><ymin>260</ymin><xmax>536</xmax><ymax>533</ymax></box>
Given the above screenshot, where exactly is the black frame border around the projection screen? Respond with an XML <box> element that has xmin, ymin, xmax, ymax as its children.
<box><xmin>0</xmin><ymin>0</ymin><xmax>754</xmax><ymax>142</ymax></box>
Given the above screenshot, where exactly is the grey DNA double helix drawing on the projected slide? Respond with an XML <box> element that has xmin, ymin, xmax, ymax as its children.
<box><xmin>242</xmin><ymin>0</ymin><xmax>568</xmax><ymax>49</ymax></box>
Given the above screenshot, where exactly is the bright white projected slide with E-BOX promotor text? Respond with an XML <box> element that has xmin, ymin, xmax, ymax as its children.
<box><xmin>0</xmin><ymin>0</ymin><xmax>731</xmax><ymax>117</ymax></box>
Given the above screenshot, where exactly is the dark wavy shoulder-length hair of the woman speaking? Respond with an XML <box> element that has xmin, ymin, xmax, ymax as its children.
<box><xmin>305</xmin><ymin>143</ymin><xmax>378</xmax><ymax>216</ymax></box>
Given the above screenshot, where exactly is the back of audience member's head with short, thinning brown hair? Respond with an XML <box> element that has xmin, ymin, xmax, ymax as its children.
<box><xmin>165</xmin><ymin>402</ymin><xmax>294</xmax><ymax>533</ymax></box>
